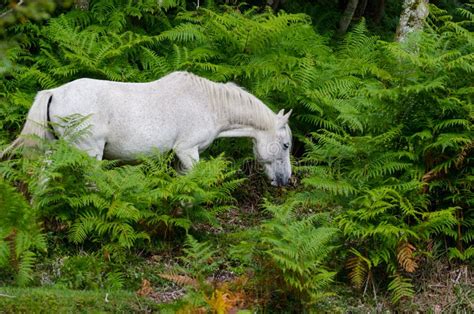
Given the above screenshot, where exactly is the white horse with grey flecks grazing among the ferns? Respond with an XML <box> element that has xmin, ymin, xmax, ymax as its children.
<box><xmin>7</xmin><ymin>72</ymin><xmax>291</xmax><ymax>186</ymax></box>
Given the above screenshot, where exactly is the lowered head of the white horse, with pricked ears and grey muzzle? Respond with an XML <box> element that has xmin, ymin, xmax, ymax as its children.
<box><xmin>254</xmin><ymin>110</ymin><xmax>291</xmax><ymax>186</ymax></box>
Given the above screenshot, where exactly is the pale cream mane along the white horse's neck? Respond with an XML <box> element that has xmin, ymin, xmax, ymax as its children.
<box><xmin>176</xmin><ymin>72</ymin><xmax>276</xmax><ymax>130</ymax></box>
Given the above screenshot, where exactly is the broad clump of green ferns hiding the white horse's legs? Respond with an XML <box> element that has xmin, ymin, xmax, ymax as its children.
<box><xmin>3</xmin><ymin>140</ymin><xmax>242</xmax><ymax>254</ymax></box>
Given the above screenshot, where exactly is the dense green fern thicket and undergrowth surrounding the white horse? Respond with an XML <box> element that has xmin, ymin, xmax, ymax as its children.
<box><xmin>0</xmin><ymin>0</ymin><xmax>474</xmax><ymax>313</ymax></box>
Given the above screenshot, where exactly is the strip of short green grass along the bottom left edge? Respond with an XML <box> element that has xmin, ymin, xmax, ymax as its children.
<box><xmin>0</xmin><ymin>287</ymin><xmax>159</xmax><ymax>313</ymax></box>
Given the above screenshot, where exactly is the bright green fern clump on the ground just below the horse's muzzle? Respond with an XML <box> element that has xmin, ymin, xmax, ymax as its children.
<box><xmin>233</xmin><ymin>203</ymin><xmax>338</xmax><ymax>306</ymax></box>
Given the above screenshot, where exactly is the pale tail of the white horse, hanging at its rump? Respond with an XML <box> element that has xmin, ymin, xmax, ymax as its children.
<box><xmin>0</xmin><ymin>90</ymin><xmax>53</xmax><ymax>160</ymax></box>
